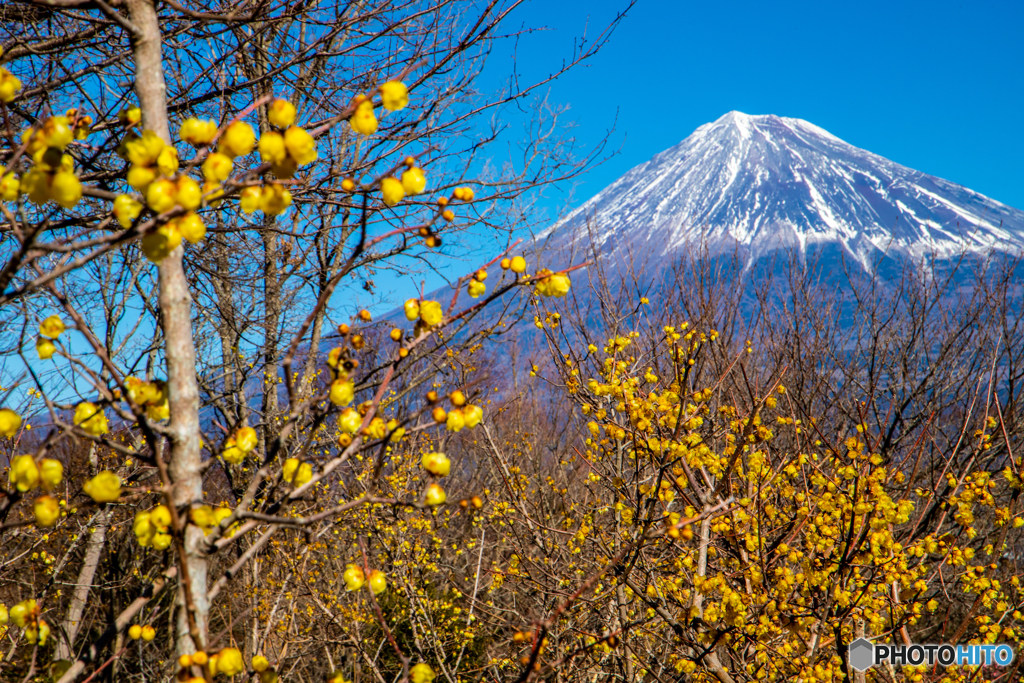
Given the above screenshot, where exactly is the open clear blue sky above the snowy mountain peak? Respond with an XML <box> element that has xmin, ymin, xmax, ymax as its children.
<box><xmin>492</xmin><ymin>0</ymin><xmax>1024</xmax><ymax>215</ymax></box>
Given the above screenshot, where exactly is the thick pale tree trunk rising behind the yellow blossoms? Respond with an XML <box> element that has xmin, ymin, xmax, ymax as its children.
<box><xmin>127</xmin><ymin>0</ymin><xmax>209</xmax><ymax>653</ymax></box>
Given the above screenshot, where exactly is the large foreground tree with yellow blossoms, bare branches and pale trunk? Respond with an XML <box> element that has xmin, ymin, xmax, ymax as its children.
<box><xmin>0</xmin><ymin>0</ymin><xmax>604</xmax><ymax>682</ymax></box>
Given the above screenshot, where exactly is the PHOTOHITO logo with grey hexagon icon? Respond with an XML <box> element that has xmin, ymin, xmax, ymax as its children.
<box><xmin>849</xmin><ymin>638</ymin><xmax>1014</xmax><ymax>671</ymax></box>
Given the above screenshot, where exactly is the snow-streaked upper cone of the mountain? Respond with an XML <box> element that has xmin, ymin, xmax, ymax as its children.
<box><xmin>548</xmin><ymin>112</ymin><xmax>1024</xmax><ymax>269</ymax></box>
